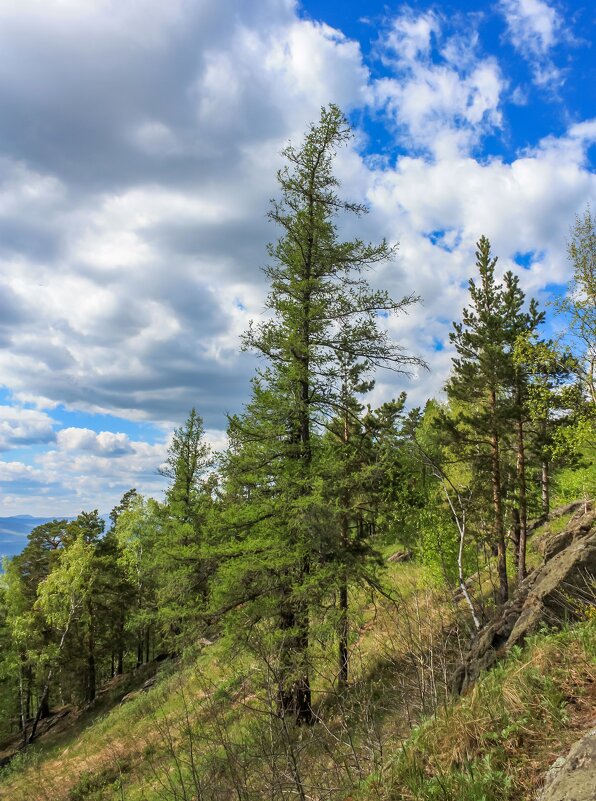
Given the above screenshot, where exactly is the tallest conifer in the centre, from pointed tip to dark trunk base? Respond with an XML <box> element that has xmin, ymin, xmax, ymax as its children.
<box><xmin>214</xmin><ymin>105</ymin><xmax>419</xmax><ymax>721</ymax></box>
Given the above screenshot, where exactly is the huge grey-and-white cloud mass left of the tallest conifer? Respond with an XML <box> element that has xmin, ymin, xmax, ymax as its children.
<box><xmin>0</xmin><ymin>0</ymin><xmax>368</xmax><ymax>426</ymax></box>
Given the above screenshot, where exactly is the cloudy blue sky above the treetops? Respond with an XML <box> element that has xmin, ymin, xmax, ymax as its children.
<box><xmin>0</xmin><ymin>0</ymin><xmax>596</xmax><ymax>516</ymax></box>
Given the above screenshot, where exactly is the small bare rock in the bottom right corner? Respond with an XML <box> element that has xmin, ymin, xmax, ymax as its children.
<box><xmin>537</xmin><ymin>728</ymin><xmax>596</xmax><ymax>801</ymax></box>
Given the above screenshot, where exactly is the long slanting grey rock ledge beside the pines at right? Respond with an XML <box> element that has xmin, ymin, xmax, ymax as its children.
<box><xmin>453</xmin><ymin>503</ymin><xmax>596</xmax><ymax>693</ymax></box>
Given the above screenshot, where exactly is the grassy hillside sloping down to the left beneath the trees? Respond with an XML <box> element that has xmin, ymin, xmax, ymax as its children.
<box><xmin>0</xmin><ymin>509</ymin><xmax>596</xmax><ymax>801</ymax></box>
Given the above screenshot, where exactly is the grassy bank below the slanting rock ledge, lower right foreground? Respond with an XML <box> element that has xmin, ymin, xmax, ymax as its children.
<box><xmin>372</xmin><ymin>620</ymin><xmax>596</xmax><ymax>801</ymax></box>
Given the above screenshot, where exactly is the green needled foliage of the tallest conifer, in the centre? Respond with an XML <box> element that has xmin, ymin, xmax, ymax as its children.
<box><xmin>214</xmin><ymin>105</ymin><xmax>419</xmax><ymax>704</ymax></box>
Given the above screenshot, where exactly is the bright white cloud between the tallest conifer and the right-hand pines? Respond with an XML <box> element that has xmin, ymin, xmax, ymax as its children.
<box><xmin>368</xmin><ymin>116</ymin><xmax>596</xmax><ymax>403</ymax></box>
